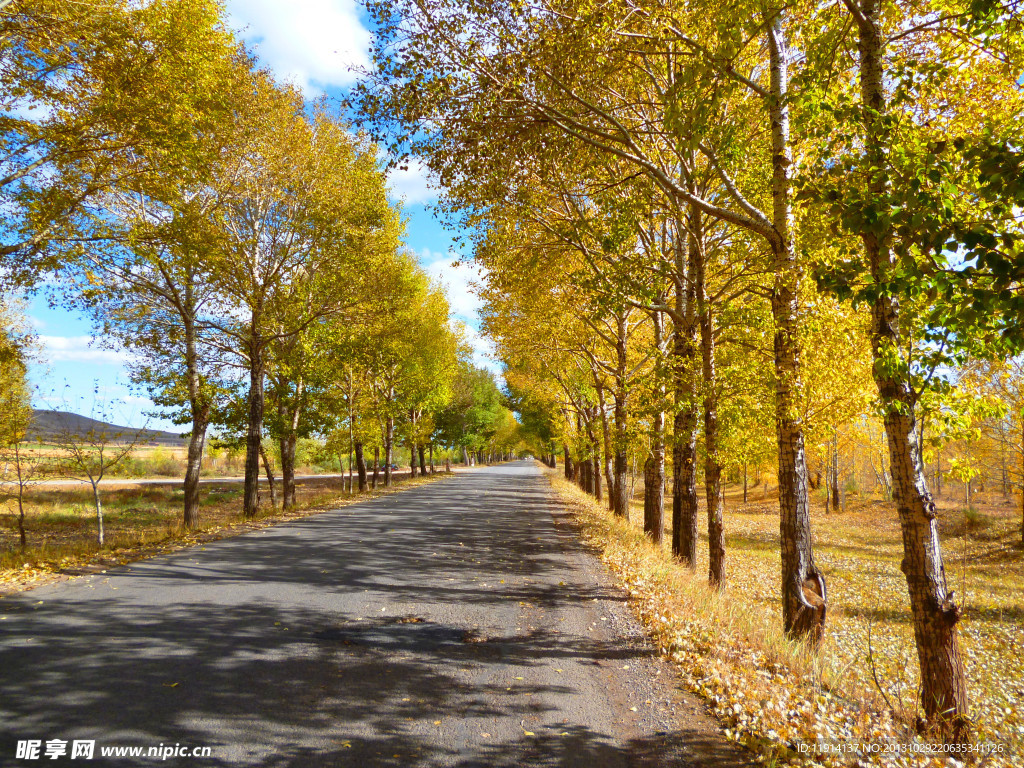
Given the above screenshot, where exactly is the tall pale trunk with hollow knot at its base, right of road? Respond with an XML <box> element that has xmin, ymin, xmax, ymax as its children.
<box><xmin>765</xmin><ymin>12</ymin><xmax>827</xmax><ymax>645</ymax></box>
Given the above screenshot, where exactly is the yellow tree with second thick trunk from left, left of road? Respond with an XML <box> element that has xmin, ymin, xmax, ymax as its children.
<box><xmin>207</xmin><ymin>96</ymin><xmax>392</xmax><ymax>517</ymax></box>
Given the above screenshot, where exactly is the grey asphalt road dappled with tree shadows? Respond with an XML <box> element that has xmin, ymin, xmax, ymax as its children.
<box><xmin>0</xmin><ymin>462</ymin><xmax>745</xmax><ymax>768</ymax></box>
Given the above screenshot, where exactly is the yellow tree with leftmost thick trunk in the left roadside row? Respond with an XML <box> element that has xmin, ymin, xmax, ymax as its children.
<box><xmin>60</xmin><ymin>12</ymin><xmax>249</xmax><ymax>528</ymax></box>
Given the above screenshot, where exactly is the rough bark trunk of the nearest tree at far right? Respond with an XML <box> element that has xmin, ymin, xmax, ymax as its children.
<box><xmin>857</xmin><ymin>0</ymin><xmax>971</xmax><ymax>743</ymax></box>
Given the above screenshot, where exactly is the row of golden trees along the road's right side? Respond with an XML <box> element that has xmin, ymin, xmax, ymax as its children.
<box><xmin>353</xmin><ymin>0</ymin><xmax>1024</xmax><ymax>743</ymax></box>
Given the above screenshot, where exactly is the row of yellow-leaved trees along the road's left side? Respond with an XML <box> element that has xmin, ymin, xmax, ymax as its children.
<box><xmin>0</xmin><ymin>0</ymin><xmax>518</xmax><ymax>540</ymax></box>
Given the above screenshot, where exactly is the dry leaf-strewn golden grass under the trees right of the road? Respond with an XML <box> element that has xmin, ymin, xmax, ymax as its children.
<box><xmin>552</xmin><ymin>473</ymin><xmax>1024</xmax><ymax>766</ymax></box>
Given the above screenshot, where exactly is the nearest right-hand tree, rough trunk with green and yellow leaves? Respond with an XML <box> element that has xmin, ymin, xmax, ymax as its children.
<box><xmin>808</xmin><ymin>0</ymin><xmax>1024</xmax><ymax>743</ymax></box>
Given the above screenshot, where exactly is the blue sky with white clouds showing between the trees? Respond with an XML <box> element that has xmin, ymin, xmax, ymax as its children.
<box><xmin>29</xmin><ymin>0</ymin><xmax>497</xmax><ymax>430</ymax></box>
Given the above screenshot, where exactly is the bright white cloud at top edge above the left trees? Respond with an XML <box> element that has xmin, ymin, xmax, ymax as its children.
<box><xmin>227</xmin><ymin>0</ymin><xmax>373</xmax><ymax>98</ymax></box>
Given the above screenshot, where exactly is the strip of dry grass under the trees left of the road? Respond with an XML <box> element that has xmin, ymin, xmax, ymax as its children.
<box><xmin>0</xmin><ymin>474</ymin><xmax>445</xmax><ymax>595</ymax></box>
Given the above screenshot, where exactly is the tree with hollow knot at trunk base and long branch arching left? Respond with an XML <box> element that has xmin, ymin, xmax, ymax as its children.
<box><xmin>358</xmin><ymin>0</ymin><xmax>826</xmax><ymax>640</ymax></box>
